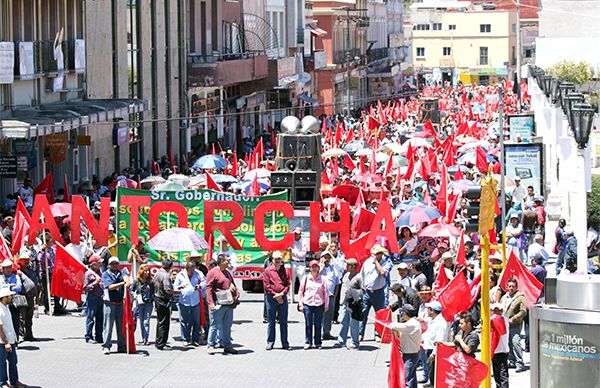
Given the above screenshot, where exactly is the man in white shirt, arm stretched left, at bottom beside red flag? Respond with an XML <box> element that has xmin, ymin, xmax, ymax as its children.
<box><xmin>390</xmin><ymin>304</ymin><xmax>422</xmax><ymax>388</ymax></box>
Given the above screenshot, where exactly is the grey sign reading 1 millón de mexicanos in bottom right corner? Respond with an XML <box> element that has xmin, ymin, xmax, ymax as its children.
<box><xmin>538</xmin><ymin>320</ymin><xmax>600</xmax><ymax>388</ymax></box>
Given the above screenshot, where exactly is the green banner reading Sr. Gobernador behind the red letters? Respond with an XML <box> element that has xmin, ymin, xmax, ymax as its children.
<box><xmin>117</xmin><ymin>187</ymin><xmax>289</xmax><ymax>278</ymax></box>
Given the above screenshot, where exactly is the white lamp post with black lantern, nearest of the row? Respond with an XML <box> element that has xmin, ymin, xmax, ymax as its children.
<box><xmin>567</xmin><ymin>103</ymin><xmax>594</xmax><ymax>274</ymax></box>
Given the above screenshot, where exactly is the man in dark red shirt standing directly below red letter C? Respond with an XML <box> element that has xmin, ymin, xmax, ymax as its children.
<box><xmin>263</xmin><ymin>251</ymin><xmax>290</xmax><ymax>350</ymax></box>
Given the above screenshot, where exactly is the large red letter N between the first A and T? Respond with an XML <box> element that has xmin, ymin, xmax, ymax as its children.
<box><xmin>71</xmin><ymin>195</ymin><xmax>110</xmax><ymax>246</ymax></box>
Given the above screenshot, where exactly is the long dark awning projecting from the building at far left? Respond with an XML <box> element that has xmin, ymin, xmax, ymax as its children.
<box><xmin>0</xmin><ymin>99</ymin><xmax>148</xmax><ymax>139</ymax></box>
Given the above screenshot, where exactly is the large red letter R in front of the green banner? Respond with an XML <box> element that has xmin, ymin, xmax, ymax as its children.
<box><xmin>204</xmin><ymin>201</ymin><xmax>244</xmax><ymax>250</ymax></box>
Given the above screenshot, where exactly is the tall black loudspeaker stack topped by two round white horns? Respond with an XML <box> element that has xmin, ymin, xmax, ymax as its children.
<box><xmin>271</xmin><ymin>116</ymin><xmax>321</xmax><ymax>207</ymax></box>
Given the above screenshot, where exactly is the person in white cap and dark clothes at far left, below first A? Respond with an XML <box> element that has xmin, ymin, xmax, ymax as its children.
<box><xmin>17</xmin><ymin>246</ymin><xmax>38</xmax><ymax>341</ymax></box>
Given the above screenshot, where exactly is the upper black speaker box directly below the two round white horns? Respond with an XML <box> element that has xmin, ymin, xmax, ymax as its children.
<box><xmin>275</xmin><ymin>133</ymin><xmax>321</xmax><ymax>173</ymax></box>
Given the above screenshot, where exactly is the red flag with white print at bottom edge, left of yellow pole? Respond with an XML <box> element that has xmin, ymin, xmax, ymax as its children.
<box><xmin>435</xmin><ymin>343</ymin><xmax>489</xmax><ymax>388</ymax></box>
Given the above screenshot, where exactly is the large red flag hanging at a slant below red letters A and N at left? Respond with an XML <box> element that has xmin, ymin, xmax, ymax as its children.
<box><xmin>50</xmin><ymin>242</ymin><xmax>85</xmax><ymax>303</ymax></box>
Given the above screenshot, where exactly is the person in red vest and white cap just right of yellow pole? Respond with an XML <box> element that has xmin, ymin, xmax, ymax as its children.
<box><xmin>490</xmin><ymin>303</ymin><xmax>509</xmax><ymax>388</ymax></box>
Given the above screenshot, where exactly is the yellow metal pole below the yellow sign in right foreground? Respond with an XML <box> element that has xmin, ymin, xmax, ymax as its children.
<box><xmin>481</xmin><ymin>234</ymin><xmax>492</xmax><ymax>388</ymax></box>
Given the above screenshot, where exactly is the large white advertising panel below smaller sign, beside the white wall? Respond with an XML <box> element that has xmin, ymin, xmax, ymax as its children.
<box><xmin>504</xmin><ymin>144</ymin><xmax>544</xmax><ymax>195</ymax></box>
